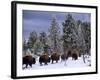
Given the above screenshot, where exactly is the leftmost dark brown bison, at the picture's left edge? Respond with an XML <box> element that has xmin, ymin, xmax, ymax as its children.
<box><xmin>23</xmin><ymin>55</ymin><xmax>36</xmax><ymax>68</ymax></box>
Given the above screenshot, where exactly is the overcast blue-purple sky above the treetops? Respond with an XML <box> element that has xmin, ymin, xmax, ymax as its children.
<box><xmin>23</xmin><ymin>10</ymin><xmax>91</xmax><ymax>40</ymax></box>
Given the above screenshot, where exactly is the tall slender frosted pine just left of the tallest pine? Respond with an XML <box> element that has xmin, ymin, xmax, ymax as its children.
<box><xmin>49</xmin><ymin>17</ymin><xmax>60</xmax><ymax>52</ymax></box>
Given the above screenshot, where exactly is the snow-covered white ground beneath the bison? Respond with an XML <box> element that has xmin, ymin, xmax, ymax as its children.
<box><xmin>23</xmin><ymin>57</ymin><xmax>91</xmax><ymax>70</ymax></box>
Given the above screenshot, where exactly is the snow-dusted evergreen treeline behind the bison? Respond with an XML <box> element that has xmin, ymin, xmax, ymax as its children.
<box><xmin>23</xmin><ymin>14</ymin><xmax>91</xmax><ymax>54</ymax></box>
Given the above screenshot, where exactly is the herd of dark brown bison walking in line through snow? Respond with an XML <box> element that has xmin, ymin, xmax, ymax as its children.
<box><xmin>23</xmin><ymin>53</ymin><xmax>78</xmax><ymax>68</ymax></box>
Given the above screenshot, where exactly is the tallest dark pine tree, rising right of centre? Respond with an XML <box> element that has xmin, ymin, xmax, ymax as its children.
<box><xmin>62</xmin><ymin>14</ymin><xmax>78</xmax><ymax>49</ymax></box>
